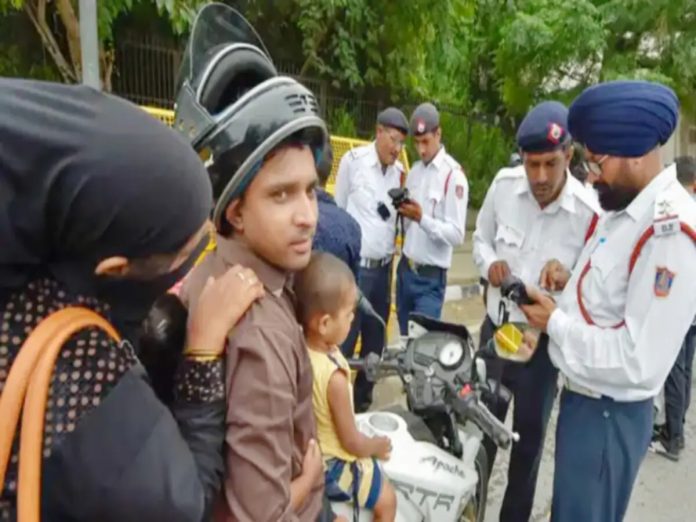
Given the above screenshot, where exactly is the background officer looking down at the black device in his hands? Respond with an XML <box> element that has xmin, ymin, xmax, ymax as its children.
<box><xmin>396</xmin><ymin>103</ymin><xmax>469</xmax><ymax>335</ymax></box>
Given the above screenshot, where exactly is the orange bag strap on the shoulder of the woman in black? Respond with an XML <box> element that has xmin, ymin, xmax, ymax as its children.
<box><xmin>0</xmin><ymin>307</ymin><xmax>120</xmax><ymax>522</ymax></box>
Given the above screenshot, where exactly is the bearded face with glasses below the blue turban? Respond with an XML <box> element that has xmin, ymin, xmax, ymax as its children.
<box><xmin>585</xmin><ymin>149</ymin><xmax>640</xmax><ymax>211</ymax></box>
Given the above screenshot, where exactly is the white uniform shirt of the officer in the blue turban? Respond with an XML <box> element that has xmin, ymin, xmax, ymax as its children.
<box><xmin>547</xmin><ymin>166</ymin><xmax>696</xmax><ymax>401</ymax></box>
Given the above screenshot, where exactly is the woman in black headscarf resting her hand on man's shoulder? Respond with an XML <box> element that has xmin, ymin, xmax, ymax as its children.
<box><xmin>0</xmin><ymin>79</ymin><xmax>262</xmax><ymax>522</ymax></box>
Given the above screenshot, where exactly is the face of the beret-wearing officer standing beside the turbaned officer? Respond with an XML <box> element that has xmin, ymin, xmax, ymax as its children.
<box><xmin>522</xmin><ymin>147</ymin><xmax>573</xmax><ymax>207</ymax></box>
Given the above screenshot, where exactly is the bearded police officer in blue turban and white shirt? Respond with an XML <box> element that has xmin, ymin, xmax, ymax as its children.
<box><xmin>523</xmin><ymin>81</ymin><xmax>696</xmax><ymax>522</ymax></box>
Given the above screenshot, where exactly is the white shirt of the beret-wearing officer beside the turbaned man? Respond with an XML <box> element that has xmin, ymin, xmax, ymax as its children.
<box><xmin>474</xmin><ymin>165</ymin><xmax>600</xmax><ymax>325</ymax></box>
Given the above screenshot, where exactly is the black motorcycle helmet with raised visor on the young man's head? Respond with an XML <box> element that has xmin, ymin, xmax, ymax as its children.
<box><xmin>174</xmin><ymin>3</ymin><xmax>328</xmax><ymax>233</ymax></box>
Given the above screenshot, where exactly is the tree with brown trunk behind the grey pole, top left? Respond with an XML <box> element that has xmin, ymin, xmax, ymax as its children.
<box><xmin>0</xmin><ymin>0</ymin><xmax>204</xmax><ymax>91</ymax></box>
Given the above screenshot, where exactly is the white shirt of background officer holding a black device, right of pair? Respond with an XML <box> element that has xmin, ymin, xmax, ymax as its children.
<box><xmin>404</xmin><ymin>147</ymin><xmax>469</xmax><ymax>269</ymax></box>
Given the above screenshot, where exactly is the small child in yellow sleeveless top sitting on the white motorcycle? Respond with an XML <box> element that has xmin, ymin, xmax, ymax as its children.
<box><xmin>295</xmin><ymin>252</ymin><xmax>396</xmax><ymax>521</ymax></box>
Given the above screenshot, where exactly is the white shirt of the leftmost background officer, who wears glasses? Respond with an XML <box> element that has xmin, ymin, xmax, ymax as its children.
<box><xmin>335</xmin><ymin>142</ymin><xmax>404</xmax><ymax>259</ymax></box>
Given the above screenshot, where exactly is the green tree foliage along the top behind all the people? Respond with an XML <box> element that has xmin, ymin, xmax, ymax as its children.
<box><xmin>0</xmin><ymin>0</ymin><xmax>696</xmax><ymax>203</ymax></box>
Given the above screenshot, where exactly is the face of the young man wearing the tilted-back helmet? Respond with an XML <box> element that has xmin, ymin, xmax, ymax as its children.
<box><xmin>226</xmin><ymin>146</ymin><xmax>317</xmax><ymax>272</ymax></box>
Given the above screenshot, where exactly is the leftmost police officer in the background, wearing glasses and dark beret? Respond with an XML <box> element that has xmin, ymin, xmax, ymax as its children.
<box><xmin>336</xmin><ymin>107</ymin><xmax>408</xmax><ymax>411</ymax></box>
